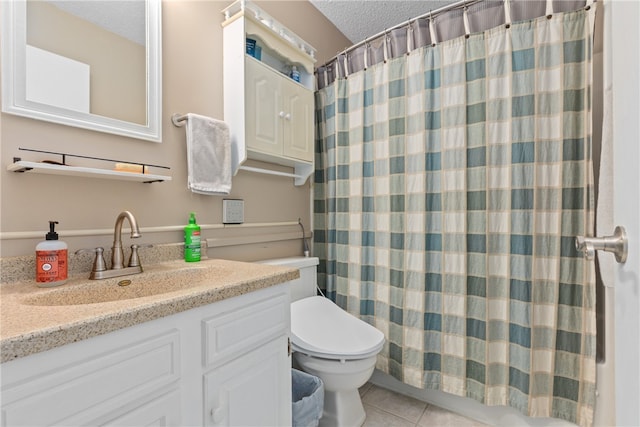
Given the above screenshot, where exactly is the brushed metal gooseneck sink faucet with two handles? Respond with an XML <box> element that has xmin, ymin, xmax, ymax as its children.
<box><xmin>76</xmin><ymin>211</ymin><xmax>151</xmax><ymax>280</ymax></box>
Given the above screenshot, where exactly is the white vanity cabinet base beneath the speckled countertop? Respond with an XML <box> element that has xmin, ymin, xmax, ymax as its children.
<box><xmin>0</xmin><ymin>283</ymin><xmax>291</xmax><ymax>427</ymax></box>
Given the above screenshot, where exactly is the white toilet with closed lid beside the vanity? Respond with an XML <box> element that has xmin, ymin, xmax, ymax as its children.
<box><xmin>262</xmin><ymin>257</ymin><xmax>384</xmax><ymax>427</ymax></box>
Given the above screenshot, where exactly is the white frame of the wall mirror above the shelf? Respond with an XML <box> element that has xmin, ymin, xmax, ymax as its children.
<box><xmin>2</xmin><ymin>0</ymin><xmax>162</xmax><ymax>142</ymax></box>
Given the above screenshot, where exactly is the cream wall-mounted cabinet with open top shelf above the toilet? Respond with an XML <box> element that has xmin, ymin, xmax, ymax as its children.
<box><xmin>222</xmin><ymin>1</ymin><xmax>315</xmax><ymax>185</ymax></box>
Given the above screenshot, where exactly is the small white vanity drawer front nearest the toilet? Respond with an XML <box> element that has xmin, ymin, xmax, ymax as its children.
<box><xmin>202</xmin><ymin>292</ymin><xmax>290</xmax><ymax>368</ymax></box>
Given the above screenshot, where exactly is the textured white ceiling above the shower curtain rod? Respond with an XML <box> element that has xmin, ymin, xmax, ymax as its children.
<box><xmin>310</xmin><ymin>0</ymin><xmax>456</xmax><ymax>44</ymax></box>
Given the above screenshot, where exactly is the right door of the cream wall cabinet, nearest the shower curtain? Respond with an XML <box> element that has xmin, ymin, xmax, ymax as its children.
<box><xmin>282</xmin><ymin>80</ymin><xmax>314</xmax><ymax>161</ymax></box>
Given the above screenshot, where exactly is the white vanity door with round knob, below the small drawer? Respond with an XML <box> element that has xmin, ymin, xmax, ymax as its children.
<box><xmin>204</xmin><ymin>336</ymin><xmax>291</xmax><ymax>426</ymax></box>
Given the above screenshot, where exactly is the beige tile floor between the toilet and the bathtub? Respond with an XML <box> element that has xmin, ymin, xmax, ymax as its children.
<box><xmin>360</xmin><ymin>383</ymin><xmax>488</xmax><ymax>427</ymax></box>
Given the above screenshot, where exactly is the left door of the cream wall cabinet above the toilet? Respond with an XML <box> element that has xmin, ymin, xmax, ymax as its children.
<box><xmin>246</xmin><ymin>58</ymin><xmax>284</xmax><ymax>155</ymax></box>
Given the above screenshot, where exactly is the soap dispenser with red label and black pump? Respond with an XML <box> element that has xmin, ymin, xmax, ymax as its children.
<box><xmin>36</xmin><ymin>221</ymin><xmax>68</xmax><ymax>288</ymax></box>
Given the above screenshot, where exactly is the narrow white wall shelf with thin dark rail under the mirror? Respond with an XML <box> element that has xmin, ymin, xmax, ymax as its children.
<box><xmin>7</xmin><ymin>160</ymin><xmax>171</xmax><ymax>183</ymax></box>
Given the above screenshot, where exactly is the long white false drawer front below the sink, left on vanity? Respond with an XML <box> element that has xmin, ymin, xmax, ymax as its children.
<box><xmin>2</xmin><ymin>330</ymin><xmax>180</xmax><ymax>426</ymax></box>
